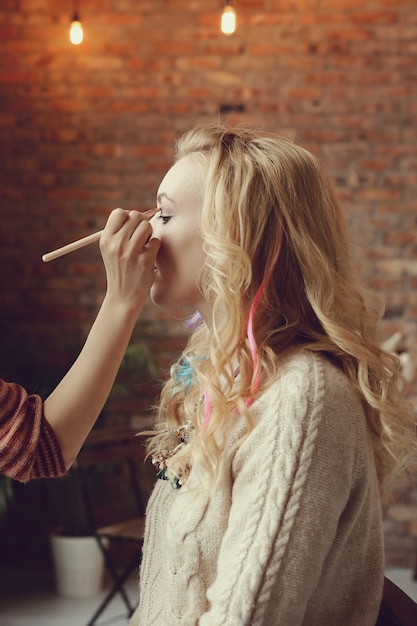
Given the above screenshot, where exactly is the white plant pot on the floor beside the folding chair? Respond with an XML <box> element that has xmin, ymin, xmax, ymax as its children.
<box><xmin>51</xmin><ymin>534</ymin><xmax>104</xmax><ymax>598</ymax></box>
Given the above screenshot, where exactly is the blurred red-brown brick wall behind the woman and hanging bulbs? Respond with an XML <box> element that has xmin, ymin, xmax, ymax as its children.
<box><xmin>0</xmin><ymin>0</ymin><xmax>417</xmax><ymax>566</ymax></box>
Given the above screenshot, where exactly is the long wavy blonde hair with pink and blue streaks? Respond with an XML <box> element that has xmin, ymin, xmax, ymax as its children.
<box><xmin>148</xmin><ymin>125</ymin><xmax>415</xmax><ymax>492</ymax></box>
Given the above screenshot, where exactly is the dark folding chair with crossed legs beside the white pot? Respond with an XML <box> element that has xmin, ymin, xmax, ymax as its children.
<box><xmin>73</xmin><ymin>429</ymin><xmax>145</xmax><ymax>626</ymax></box>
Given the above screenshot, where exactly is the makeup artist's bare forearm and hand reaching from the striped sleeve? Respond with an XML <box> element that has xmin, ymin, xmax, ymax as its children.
<box><xmin>44</xmin><ymin>209</ymin><xmax>159</xmax><ymax>468</ymax></box>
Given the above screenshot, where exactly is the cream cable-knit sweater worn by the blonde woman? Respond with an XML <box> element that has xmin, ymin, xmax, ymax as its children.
<box><xmin>130</xmin><ymin>352</ymin><xmax>384</xmax><ymax>626</ymax></box>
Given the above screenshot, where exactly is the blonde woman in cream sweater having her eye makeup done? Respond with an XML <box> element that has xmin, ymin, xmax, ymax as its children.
<box><xmin>131</xmin><ymin>126</ymin><xmax>414</xmax><ymax>626</ymax></box>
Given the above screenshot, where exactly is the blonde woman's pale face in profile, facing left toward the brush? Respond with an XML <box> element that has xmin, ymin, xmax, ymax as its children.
<box><xmin>151</xmin><ymin>156</ymin><xmax>205</xmax><ymax>316</ymax></box>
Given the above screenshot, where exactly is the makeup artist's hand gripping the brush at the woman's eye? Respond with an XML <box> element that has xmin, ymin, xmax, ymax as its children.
<box><xmin>100</xmin><ymin>209</ymin><xmax>160</xmax><ymax>313</ymax></box>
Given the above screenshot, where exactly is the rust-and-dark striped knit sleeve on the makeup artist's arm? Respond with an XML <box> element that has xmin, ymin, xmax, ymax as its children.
<box><xmin>0</xmin><ymin>379</ymin><xmax>66</xmax><ymax>482</ymax></box>
